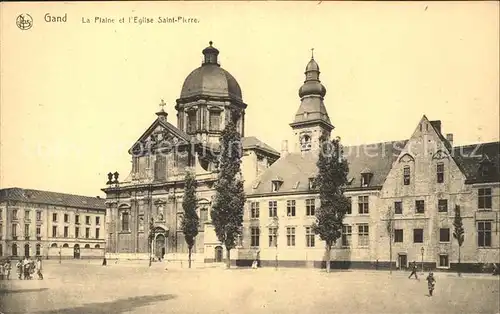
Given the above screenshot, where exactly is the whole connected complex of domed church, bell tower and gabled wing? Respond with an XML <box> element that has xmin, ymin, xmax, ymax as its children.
<box><xmin>103</xmin><ymin>42</ymin><xmax>500</xmax><ymax>271</ymax></box>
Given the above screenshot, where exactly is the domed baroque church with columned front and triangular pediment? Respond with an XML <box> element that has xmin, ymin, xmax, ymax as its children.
<box><xmin>103</xmin><ymin>42</ymin><xmax>279</xmax><ymax>261</ymax></box>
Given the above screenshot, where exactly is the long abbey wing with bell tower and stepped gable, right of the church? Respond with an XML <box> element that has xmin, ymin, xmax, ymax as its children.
<box><xmin>239</xmin><ymin>55</ymin><xmax>500</xmax><ymax>269</ymax></box>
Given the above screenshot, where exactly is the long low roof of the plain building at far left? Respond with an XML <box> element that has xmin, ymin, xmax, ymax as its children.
<box><xmin>0</xmin><ymin>187</ymin><xmax>106</xmax><ymax>210</ymax></box>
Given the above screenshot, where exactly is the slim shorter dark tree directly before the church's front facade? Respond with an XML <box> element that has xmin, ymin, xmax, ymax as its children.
<box><xmin>181</xmin><ymin>171</ymin><xmax>200</xmax><ymax>268</ymax></box>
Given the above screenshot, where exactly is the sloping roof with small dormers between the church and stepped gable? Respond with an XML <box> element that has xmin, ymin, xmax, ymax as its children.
<box><xmin>246</xmin><ymin>140</ymin><xmax>407</xmax><ymax>195</ymax></box>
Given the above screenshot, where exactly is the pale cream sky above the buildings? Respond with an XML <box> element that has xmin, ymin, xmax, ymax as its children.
<box><xmin>0</xmin><ymin>1</ymin><xmax>500</xmax><ymax>196</ymax></box>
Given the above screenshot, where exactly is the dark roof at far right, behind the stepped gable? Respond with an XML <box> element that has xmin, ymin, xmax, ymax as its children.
<box><xmin>452</xmin><ymin>142</ymin><xmax>500</xmax><ymax>183</ymax></box>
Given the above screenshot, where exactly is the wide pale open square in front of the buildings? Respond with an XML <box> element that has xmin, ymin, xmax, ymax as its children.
<box><xmin>0</xmin><ymin>261</ymin><xmax>500</xmax><ymax>314</ymax></box>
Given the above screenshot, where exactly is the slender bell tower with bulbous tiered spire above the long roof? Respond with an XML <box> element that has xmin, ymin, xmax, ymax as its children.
<box><xmin>290</xmin><ymin>48</ymin><xmax>334</xmax><ymax>152</ymax></box>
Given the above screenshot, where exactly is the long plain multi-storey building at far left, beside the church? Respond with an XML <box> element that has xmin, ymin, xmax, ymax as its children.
<box><xmin>0</xmin><ymin>188</ymin><xmax>106</xmax><ymax>259</ymax></box>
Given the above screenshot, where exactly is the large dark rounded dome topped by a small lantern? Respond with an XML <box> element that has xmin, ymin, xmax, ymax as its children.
<box><xmin>180</xmin><ymin>42</ymin><xmax>242</xmax><ymax>101</ymax></box>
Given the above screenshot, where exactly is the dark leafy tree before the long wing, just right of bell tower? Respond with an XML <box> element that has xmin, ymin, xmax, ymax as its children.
<box><xmin>312</xmin><ymin>133</ymin><xmax>350</xmax><ymax>272</ymax></box>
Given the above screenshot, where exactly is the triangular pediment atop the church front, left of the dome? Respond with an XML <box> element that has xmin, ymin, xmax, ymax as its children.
<box><xmin>129</xmin><ymin>120</ymin><xmax>190</xmax><ymax>155</ymax></box>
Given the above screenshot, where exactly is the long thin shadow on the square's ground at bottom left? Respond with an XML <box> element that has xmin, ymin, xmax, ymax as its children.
<box><xmin>35</xmin><ymin>294</ymin><xmax>175</xmax><ymax>314</ymax></box>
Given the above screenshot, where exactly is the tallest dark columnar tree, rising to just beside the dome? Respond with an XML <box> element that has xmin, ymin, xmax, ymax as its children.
<box><xmin>210</xmin><ymin>110</ymin><xmax>245</xmax><ymax>268</ymax></box>
